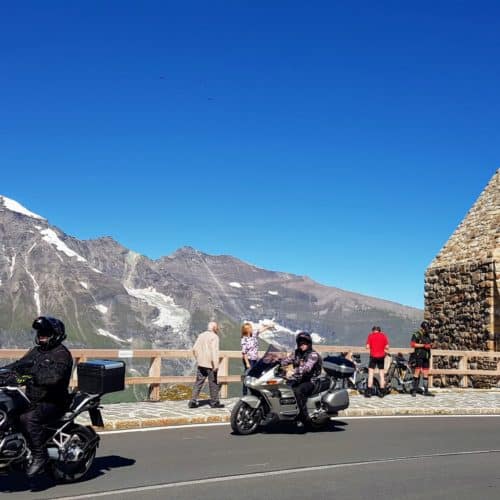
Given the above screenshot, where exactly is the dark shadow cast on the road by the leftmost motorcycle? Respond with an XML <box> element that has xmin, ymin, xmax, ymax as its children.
<box><xmin>0</xmin><ymin>455</ymin><xmax>135</xmax><ymax>493</ymax></box>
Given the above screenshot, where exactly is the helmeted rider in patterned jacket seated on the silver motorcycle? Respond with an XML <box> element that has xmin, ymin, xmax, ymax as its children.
<box><xmin>281</xmin><ymin>332</ymin><xmax>322</xmax><ymax>424</ymax></box>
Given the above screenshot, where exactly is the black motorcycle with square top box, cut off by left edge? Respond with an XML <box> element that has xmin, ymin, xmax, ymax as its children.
<box><xmin>0</xmin><ymin>360</ymin><xmax>125</xmax><ymax>483</ymax></box>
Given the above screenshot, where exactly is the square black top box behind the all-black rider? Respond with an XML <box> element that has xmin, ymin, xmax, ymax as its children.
<box><xmin>77</xmin><ymin>359</ymin><xmax>125</xmax><ymax>394</ymax></box>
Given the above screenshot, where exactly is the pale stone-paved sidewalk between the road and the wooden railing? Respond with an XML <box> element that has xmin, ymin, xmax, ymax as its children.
<box><xmin>78</xmin><ymin>390</ymin><xmax>500</xmax><ymax>430</ymax></box>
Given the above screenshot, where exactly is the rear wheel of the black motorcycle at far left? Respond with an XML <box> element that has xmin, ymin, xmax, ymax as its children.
<box><xmin>51</xmin><ymin>425</ymin><xmax>97</xmax><ymax>483</ymax></box>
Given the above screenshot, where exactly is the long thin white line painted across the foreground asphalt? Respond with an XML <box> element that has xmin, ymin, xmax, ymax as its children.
<box><xmin>58</xmin><ymin>449</ymin><xmax>500</xmax><ymax>500</ymax></box>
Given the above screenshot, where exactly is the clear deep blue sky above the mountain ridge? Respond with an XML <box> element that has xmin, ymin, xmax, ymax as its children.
<box><xmin>0</xmin><ymin>0</ymin><xmax>500</xmax><ymax>307</ymax></box>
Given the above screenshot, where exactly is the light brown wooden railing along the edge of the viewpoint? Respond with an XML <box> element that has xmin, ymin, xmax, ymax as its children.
<box><xmin>0</xmin><ymin>345</ymin><xmax>500</xmax><ymax>401</ymax></box>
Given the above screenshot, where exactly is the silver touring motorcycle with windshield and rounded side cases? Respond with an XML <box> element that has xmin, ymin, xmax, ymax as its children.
<box><xmin>231</xmin><ymin>345</ymin><xmax>355</xmax><ymax>435</ymax></box>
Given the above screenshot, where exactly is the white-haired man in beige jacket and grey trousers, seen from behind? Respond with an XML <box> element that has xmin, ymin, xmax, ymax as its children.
<box><xmin>188</xmin><ymin>321</ymin><xmax>224</xmax><ymax>408</ymax></box>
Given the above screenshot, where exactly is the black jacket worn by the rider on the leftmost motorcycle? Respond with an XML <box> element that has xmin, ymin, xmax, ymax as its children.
<box><xmin>6</xmin><ymin>344</ymin><xmax>73</xmax><ymax>408</ymax></box>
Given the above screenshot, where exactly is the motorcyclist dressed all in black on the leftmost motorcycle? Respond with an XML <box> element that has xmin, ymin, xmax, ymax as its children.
<box><xmin>6</xmin><ymin>316</ymin><xmax>73</xmax><ymax>476</ymax></box>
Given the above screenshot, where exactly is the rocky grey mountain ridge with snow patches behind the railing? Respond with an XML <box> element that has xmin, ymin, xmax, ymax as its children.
<box><xmin>0</xmin><ymin>196</ymin><xmax>422</xmax><ymax>349</ymax></box>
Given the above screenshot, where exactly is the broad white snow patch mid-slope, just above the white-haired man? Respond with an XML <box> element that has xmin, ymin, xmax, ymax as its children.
<box><xmin>125</xmin><ymin>287</ymin><xmax>190</xmax><ymax>334</ymax></box>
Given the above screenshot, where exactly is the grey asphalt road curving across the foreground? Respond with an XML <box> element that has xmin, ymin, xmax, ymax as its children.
<box><xmin>0</xmin><ymin>417</ymin><xmax>500</xmax><ymax>500</ymax></box>
